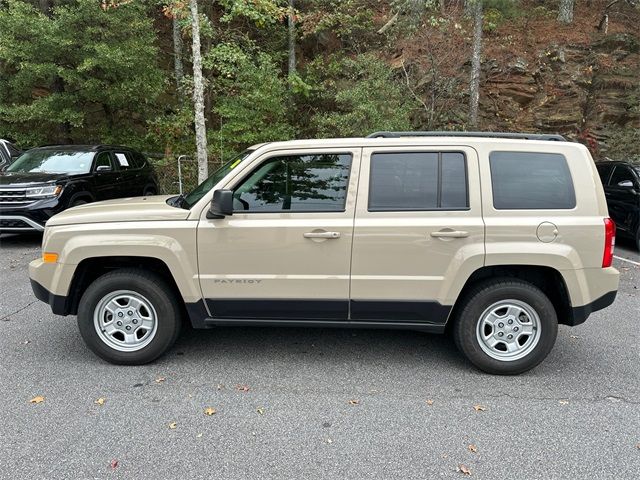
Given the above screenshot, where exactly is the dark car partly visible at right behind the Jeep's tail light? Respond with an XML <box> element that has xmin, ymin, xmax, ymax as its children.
<box><xmin>596</xmin><ymin>162</ymin><xmax>640</xmax><ymax>250</ymax></box>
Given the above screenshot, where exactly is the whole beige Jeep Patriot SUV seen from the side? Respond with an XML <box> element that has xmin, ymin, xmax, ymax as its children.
<box><xmin>29</xmin><ymin>132</ymin><xmax>618</xmax><ymax>374</ymax></box>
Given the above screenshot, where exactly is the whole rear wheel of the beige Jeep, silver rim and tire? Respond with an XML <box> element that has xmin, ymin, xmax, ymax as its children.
<box><xmin>454</xmin><ymin>279</ymin><xmax>558</xmax><ymax>375</ymax></box>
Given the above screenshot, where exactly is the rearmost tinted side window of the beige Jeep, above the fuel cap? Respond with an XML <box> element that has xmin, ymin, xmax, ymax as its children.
<box><xmin>489</xmin><ymin>152</ymin><xmax>576</xmax><ymax>210</ymax></box>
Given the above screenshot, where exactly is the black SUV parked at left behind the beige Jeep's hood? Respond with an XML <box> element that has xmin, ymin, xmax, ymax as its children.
<box><xmin>0</xmin><ymin>145</ymin><xmax>158</xmax><ymax>232</ymax></box>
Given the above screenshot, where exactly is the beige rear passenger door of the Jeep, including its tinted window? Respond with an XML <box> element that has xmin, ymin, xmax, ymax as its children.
<box><xmin>351</xmin><ymin>146</ymin><xmax>484</xmax><ymax>325</ymax></box>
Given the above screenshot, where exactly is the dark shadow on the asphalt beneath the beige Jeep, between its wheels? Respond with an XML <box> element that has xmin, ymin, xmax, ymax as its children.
<box><xmin>169</xmin><ymin>327</ymin><xmax>471</xmax><ymax>370</ymax></box>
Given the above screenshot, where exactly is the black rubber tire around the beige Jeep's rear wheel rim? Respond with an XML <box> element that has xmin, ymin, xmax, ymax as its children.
<box><xmin>453</xmin><ymin>278</ymin><xmax>558</xmax><ymax>375</ymax></box>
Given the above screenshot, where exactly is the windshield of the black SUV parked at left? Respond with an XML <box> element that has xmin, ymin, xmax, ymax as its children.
<box><xmin>6</xmin><ymin>150</ymin><xmax>94</xmax><ymax>173</ymax></box>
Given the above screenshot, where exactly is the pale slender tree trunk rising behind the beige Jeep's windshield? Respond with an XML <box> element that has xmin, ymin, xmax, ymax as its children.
<box><xmin>189</xmin><ymin>0</ymin><xmax>209</xmax><ymax>184</ymax></box>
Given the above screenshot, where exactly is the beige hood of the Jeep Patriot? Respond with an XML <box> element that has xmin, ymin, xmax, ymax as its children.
<box><xmin>47</xmin><ymin>195</ymin><xmax>189</xmax><ymax>227</ymax></box>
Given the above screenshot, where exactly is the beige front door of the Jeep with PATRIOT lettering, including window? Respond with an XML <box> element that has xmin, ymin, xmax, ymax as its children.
<box><xmin>198</xmin><ymin>148</ymin><xmax>361</xmax><ymax>321</ymax></box>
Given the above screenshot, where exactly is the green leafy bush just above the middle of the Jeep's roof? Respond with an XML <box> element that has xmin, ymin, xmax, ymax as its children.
<box><xmin>309</xmin><ymin>54</ymin><xmax>418</xmax><ymax>137</ymax></box>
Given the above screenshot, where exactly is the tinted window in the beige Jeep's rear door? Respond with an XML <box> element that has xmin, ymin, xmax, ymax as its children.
<box><xmin>369</xmin><ymin>152</ymin><xmax>469</xmax><ymax>211</ymax></box>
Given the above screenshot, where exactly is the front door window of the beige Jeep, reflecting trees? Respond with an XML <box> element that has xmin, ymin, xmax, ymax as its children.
<box><xmin>233</xmin><ymin>153</ymin><xmax>351</xmax><ymax>212</ymax></box>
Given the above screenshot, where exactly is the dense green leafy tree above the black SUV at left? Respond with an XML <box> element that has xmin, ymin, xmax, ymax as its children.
<box><xmin>0</xmin><ymin>0</ymin><xmax>165</xmax><ymax>146</ymax></box>
